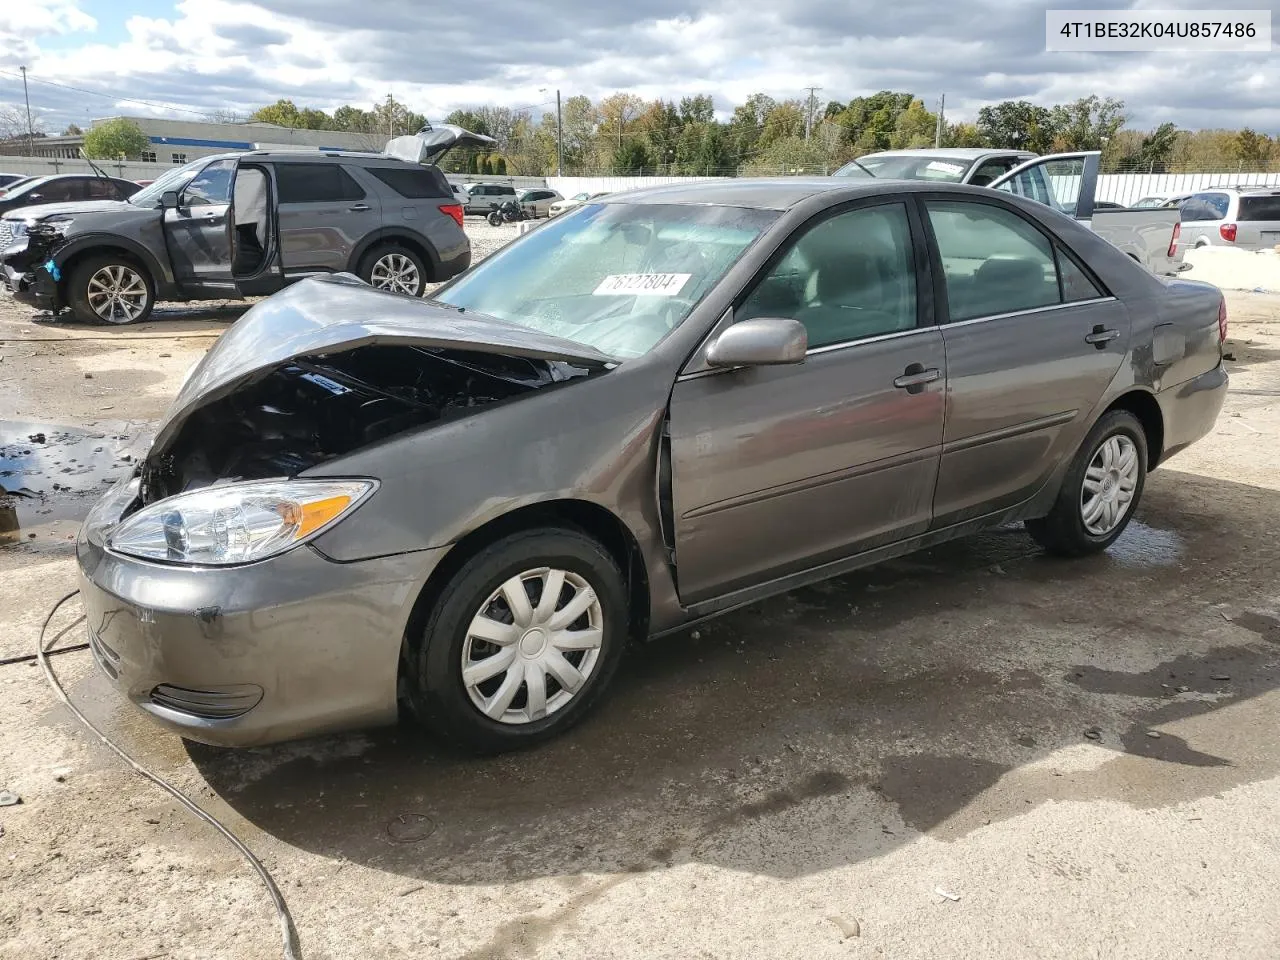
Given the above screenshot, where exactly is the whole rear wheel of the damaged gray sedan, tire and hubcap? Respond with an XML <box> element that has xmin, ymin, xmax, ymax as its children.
<box><xmin>1027</xmin><ymin>410</ymin><xmax>1147</xmax><ymax>557</ymax></box>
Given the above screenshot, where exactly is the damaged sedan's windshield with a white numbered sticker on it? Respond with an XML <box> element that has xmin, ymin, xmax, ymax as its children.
<box><xmin>434</xmin><ymin>204</ymin><xmax>778</xmax><ymax>360</ymax></box>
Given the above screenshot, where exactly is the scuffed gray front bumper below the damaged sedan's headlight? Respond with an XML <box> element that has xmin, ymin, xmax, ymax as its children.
<box><xmin>76</xmin><ymin>483</ymin><xmax>444</xmax><ymax>746</ymax></box>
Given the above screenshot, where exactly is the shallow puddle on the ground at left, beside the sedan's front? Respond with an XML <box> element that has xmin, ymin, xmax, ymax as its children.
<box><xmin>0</xmin><ymin>420</ymin><xmax>148</xmax><ymax>545</ymax></box>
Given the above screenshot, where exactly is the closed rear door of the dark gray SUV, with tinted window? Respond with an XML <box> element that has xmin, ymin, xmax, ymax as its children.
<box><xmin>268</xmin><ymin>160</ymin><xmax>381</xmax><ymax>276</ymax></box>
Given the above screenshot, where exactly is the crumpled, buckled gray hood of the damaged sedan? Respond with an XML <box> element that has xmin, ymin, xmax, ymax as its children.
<box><xmin>154</xmin><ymin>274</ymin><xmax>616</xmax><ymax>449</ymax></box>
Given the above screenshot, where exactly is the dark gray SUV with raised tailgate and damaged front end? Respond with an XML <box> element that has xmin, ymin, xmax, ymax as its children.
<box><xmin>0</xmin><ymin>127</ymin><xmax>490</xmax><ymax>324</ymax></box>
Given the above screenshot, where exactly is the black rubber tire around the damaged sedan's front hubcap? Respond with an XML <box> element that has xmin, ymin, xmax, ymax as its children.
<box><xmin>406</xmin><ymin>527</ymin><xmax>630</xmax><ymax>754</ymax></box>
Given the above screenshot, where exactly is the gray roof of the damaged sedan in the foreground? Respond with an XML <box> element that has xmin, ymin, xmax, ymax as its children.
<box><xmin>600</xmin><ymin>177</ymin><xmax>991</xmax><ymax>210</ymax></box>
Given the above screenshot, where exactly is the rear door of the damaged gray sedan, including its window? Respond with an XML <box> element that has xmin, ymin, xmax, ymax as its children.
<box><xmin>924</xmin><ymin>196</ymin><xmax>1129</xmax><ymax>526</ymax></box>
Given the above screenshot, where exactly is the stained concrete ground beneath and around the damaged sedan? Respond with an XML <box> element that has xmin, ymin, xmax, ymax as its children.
<box><xmin>0</xmin><ymin>235</ymin><xmax>1280</xmax><ymax>960</ymax></box>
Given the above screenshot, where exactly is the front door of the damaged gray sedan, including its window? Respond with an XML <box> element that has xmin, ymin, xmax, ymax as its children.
<box><xmin>669</xmin><ymin>202</ymin><xmax>946</xmax><ymax>603</ymax></box>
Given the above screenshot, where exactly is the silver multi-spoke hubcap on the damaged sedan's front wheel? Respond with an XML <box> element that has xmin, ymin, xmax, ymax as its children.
<box><xmin>462</xmin><ymin>567</ymin><xmax>604</xmax><ymax>724</ymax></box>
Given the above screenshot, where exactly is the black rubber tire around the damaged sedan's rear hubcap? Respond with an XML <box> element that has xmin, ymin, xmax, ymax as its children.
<box><xmin>1027</xmin><ymin>410</ymin><xmax>1148</xmax><ymax>557</ymax></box>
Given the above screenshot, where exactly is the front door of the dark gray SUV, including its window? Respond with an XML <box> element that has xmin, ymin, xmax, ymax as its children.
<box><xmin>164</xmin><ymin>160</ymin><xmax>236</xmax><ymax>291</ymax></box>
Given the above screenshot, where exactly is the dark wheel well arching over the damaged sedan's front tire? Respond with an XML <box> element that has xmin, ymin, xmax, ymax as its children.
<box><xmin>404</xmin><ymin>499</ymin><xmax>649</xmax><ymax>670</ymax></box>
